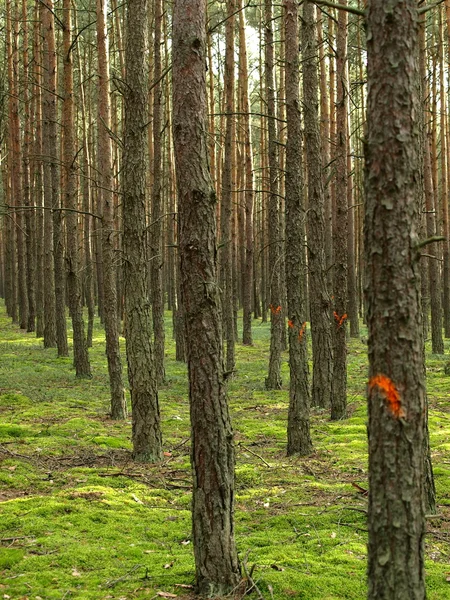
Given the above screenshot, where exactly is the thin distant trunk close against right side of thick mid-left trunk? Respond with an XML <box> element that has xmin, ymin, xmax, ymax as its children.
<box><xmin>149</xmin><ymin>0</ymin><xmax>165</xmax><ymax>384</ymax></box>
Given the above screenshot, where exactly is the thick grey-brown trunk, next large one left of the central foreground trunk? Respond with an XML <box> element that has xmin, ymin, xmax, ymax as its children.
<box><xmin>122</xmin><ymin>0</ymin><xmax>162</xmax><ymax>462</ymax></box>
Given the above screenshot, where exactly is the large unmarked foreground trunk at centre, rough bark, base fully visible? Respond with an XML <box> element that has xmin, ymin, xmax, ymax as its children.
<box><xmin>173</xmin><ymin>0</ymin><xmax>240</xmax><ymax>597</ymax></box>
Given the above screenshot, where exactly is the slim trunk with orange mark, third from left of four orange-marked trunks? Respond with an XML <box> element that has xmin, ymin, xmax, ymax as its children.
<box><xmin>331</xmin><ymin>0</ymin><xmax>348</xmax><ymax>420</ymax></box>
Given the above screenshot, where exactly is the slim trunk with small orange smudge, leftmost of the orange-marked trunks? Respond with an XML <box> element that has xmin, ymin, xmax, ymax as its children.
<box><xmin>264</xmin><ymin>0</ymin><xmax>284</xmax><ymax>390</ymax></box>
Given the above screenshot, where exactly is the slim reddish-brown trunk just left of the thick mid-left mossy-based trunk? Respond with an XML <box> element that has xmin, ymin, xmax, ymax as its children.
<box><xmin>97</xmin><ymin>0</ymin><xmax>127</xmax><ymax>419</ymax></box>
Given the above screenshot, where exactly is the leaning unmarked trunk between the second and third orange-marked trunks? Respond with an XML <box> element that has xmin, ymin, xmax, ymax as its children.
<box><xmin>302</xmin><ymin>2</ymin><xmax>333</xmax><ymax>408</ymax></box>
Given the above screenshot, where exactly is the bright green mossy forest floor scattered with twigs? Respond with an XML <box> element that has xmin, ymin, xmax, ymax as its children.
<box><xmin>0</xmin><ymin>306</ymin><xmax>450</xmax><ymax>600</ymax></box>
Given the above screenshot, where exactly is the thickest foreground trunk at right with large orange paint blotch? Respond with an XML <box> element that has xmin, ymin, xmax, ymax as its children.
<box><xmin>365</xmin><ymin>0</ymin><xmax>425</xmax><ymax>600</ymax></box>
